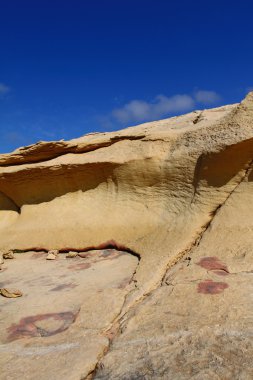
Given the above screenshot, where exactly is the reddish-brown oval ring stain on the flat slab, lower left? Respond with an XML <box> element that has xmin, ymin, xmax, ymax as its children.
<box><xmin>7</xmin><ymin>311</ymin><xmax>79</xmax><ymax>342</ymax></box>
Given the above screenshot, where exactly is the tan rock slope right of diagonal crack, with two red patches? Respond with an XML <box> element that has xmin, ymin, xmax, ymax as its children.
<box><xmin>95</xmin><ymin>173</ymin><xmax>253</xmax><ymax>380</ymax></box>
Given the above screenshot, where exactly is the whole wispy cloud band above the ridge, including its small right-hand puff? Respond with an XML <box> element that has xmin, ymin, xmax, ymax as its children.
<box><xmin>111</xmin><ymin>90</ymin><xmax>221</xmax><ymax>124</ymax></box>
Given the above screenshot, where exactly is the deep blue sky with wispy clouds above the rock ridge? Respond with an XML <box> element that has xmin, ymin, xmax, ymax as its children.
<box><xmin>0</xmin><ymin>0</ymin><xmax>253</xmax><ymax>152</ymax></box>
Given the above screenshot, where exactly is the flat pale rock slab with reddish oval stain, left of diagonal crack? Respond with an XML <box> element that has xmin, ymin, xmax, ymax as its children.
<box><xmin>0</xmin><ymin>250</ymin><xmax>138</xmax><ymax>380</ymax></box>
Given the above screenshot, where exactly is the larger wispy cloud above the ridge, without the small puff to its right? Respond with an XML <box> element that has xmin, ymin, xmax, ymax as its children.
<box><xmin>112</xmin><ymin>95</ymin><xmax>195</xmax><ymax>123</ymax></box>
